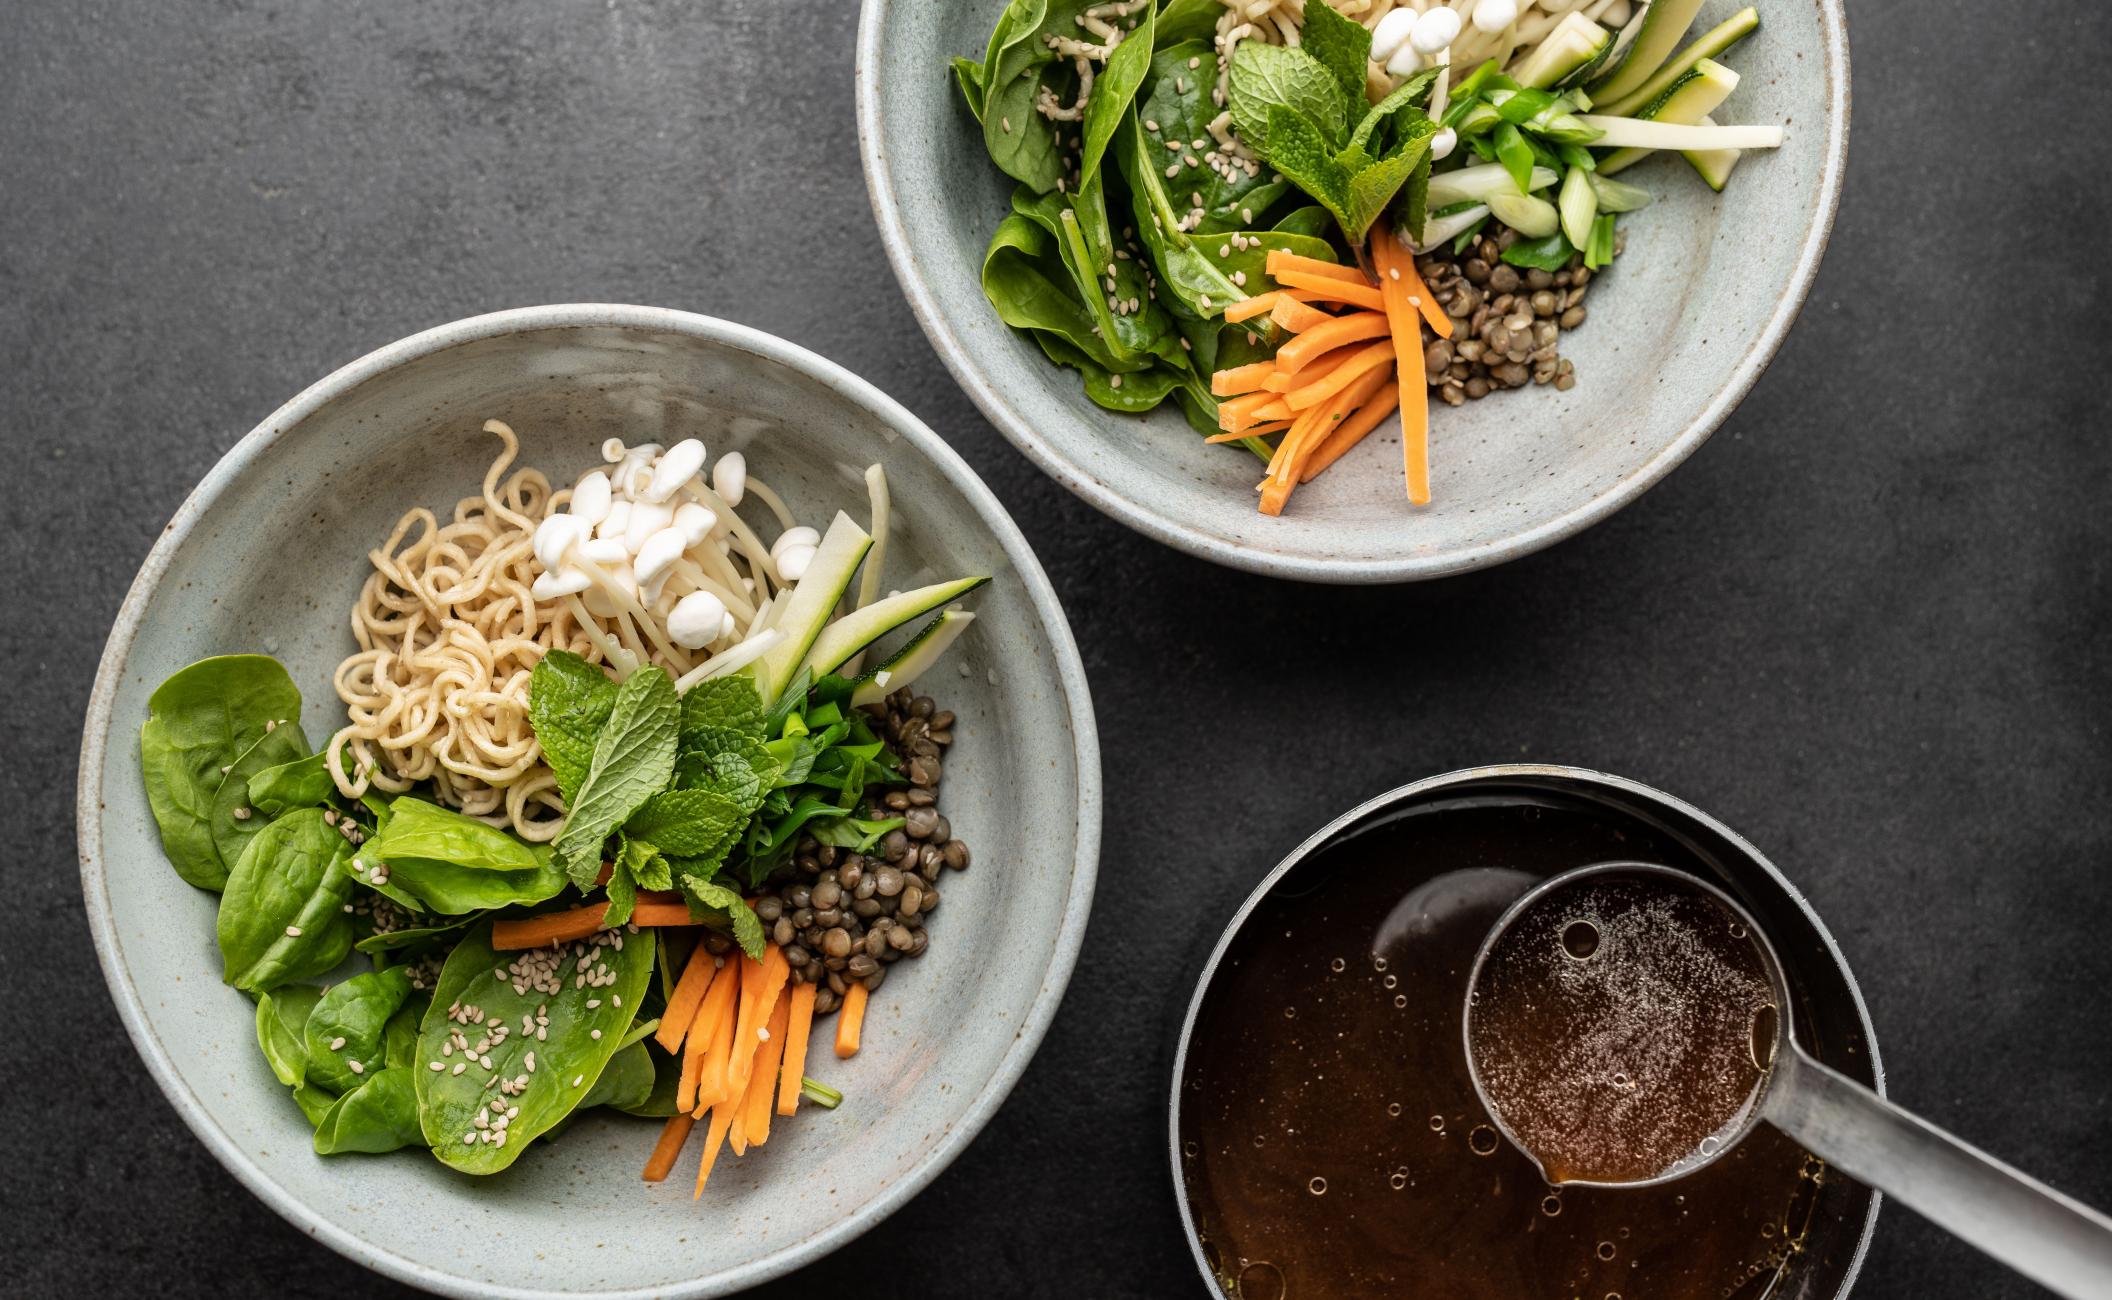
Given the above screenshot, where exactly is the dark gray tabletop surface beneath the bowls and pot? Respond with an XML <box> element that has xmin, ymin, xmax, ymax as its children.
<box><xmin>0</xmin><ymin>0</ymin><xmax>2112</xmax><ymax>1300</ymax></box>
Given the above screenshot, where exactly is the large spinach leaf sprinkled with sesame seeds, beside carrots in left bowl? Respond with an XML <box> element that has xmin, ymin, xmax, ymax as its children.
<box><xmin>410</xmin><ymin>924</ymin><xmax>653</xmax><ymax>1173</ymax></box>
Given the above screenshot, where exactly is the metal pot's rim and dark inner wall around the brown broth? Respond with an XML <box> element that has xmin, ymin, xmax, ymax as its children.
<box><xmin>1168</xmin><ymin>764</ymin><xmax>1884</xmax><ymax>1300</ymax></box>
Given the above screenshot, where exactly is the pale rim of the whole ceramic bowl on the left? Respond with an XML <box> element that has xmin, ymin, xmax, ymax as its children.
<box><xmin>74</xmin><ymin>304</ymin><xmax>1100</xmax><ymax>1300</ymax></box>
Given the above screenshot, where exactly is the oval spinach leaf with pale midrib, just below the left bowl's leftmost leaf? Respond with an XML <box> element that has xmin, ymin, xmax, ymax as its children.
<box><xmin>218</xmin><ymin>808</ymin><xmax>353</xmax><ymax>992</ymax></box>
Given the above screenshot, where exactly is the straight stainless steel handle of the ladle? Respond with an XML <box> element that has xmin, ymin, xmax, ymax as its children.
<box><xmin>1766</xmin><ymin>1047</ymin><xmax>2112</xmax><ymax>1300</ymax></box>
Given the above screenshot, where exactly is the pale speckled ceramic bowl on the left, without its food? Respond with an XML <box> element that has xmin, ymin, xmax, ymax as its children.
<box><xmin>78</xmin><ymin>306</ymin><xmax>1100</xmax><ymax>1296</ymax></box>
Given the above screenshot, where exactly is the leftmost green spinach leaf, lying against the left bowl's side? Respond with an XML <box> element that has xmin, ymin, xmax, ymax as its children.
<box><xmin>139</xmin><ymin>654</ymin><xmax>306</xmax><ymax>888</ymax></box>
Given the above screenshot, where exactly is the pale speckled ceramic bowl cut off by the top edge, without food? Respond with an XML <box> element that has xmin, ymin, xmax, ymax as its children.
<box><xmin>857</xmin><ymin>0</ymin><xmax>1848</xmax><ymax>582</ymax></box>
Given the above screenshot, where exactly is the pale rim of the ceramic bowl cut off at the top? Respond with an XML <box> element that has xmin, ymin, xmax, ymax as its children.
<box><xmin>855</xmin><ymin>0</ymin><xmax>1852</xmax><ymax>582</ymax></box>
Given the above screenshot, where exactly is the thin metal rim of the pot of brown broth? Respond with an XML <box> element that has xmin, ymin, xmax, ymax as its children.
<box><xmin>1166</xmin><ymin>762</ymin><xmax>1886</xmax><ymax>1298</ymax></box>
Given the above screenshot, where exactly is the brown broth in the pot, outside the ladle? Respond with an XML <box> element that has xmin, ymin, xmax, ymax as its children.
<box><xmin>1181</xmin><ymin>796</ymin><xmax>1846</xmax><ymax>1300</ymax></box>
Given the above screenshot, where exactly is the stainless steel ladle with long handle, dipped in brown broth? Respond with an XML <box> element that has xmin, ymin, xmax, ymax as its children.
<box><xmin>1462</xmin><ymin>863</ymin><xmax>2112</xmax><ymax>1300</ymax></box>
